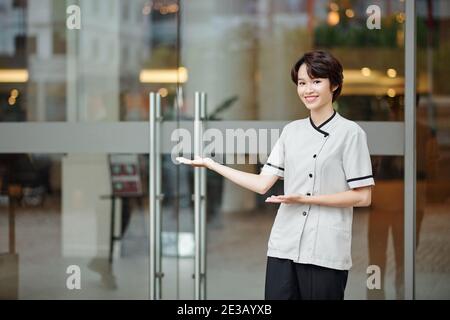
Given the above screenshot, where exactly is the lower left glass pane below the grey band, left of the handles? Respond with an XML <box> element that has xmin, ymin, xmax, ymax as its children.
<box><xmin>0</xmin><ymin>153</ymin><xmax>148</xmax><ymax>299</ymax></box>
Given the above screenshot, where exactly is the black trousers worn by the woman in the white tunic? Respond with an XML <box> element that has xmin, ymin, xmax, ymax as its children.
<box><xmin>265</xmin><ymin>257</ymin><xmax>348</xmax><ymax>300</ymax></box>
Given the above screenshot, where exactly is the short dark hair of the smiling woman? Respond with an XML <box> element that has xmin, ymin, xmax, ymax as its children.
<box><xmin>291</xmin><ymin>50</ymin><xmax>344</xmax><ymax>102</ymax></box>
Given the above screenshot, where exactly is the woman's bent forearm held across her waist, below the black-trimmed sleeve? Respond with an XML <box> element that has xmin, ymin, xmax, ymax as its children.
<box><xmin>302</xmin><ymin>190</ymin><xmax>371</xmax><ymax>208</ymax></box>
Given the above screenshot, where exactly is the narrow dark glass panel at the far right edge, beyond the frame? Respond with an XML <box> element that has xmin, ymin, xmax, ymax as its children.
<box><xmin>416</xmin><ymin>0</ymin><xmax>450</xmax><ymax>299</ymax></box>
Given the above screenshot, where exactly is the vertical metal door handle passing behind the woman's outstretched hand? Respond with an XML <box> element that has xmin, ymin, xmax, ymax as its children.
<box><xmin>194</xmin><ymin>92</ymin><xmax>206</xmax><ymax>300</ymax></box>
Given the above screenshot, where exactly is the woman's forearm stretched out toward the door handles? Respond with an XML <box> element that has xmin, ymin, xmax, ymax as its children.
<box><xmin>208</xmin><ymin>162</ymin><xmax>273</xmax><ymax>194</ymax></box>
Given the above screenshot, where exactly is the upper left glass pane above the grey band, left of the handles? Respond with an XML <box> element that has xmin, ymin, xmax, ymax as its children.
<box><xmin>0</xmin><ymin>0</ymin><xmax>179</xmax><ymax>122</ymax></box>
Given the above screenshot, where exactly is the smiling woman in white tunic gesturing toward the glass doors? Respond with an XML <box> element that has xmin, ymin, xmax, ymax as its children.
<box><xmin>177</xmin><ymin>51</ymin><xmax>375</xmax><ymax>300</ymax></box>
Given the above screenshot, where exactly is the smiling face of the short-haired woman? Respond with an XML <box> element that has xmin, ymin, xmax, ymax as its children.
<box><xmin>297</xmin><ymin>64</ymin><xmax>333</xmax><ymax>111</ymax></box>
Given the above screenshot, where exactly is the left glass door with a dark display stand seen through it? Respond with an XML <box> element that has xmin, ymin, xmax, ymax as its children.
<box><xmin>0</xmin><ymin>0</ymin><xmax>186</xmax><ymax>299</ymax></box>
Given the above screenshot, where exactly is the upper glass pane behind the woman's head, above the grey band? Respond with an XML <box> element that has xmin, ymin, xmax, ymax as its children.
<box><xmin>181</xmin><ymin>0</ymin><xmax>405</xmax><ymax>121</ymax></box>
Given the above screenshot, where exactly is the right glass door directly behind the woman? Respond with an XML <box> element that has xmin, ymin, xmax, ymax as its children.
<box><xmin>180</xmin><ymin>0</ymin><xmax>405</xmax><ymax>299</ymax></box>
